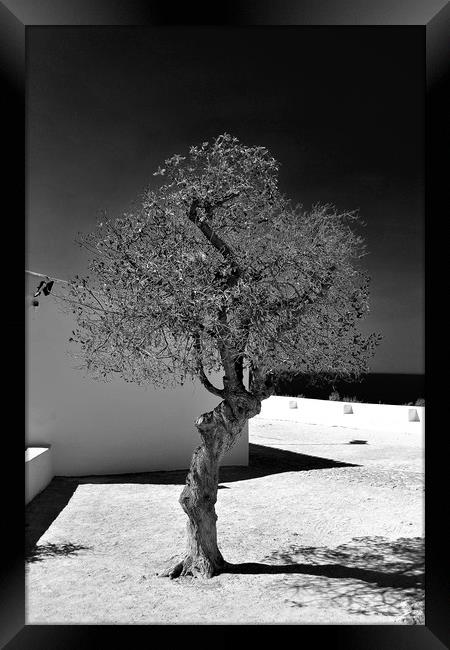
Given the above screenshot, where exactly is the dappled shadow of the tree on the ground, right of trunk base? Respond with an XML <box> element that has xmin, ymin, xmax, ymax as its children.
<box><xmin>226</xmin><ymin>537</ymin><xmax>425</xmax><ymax>624</ymax></box>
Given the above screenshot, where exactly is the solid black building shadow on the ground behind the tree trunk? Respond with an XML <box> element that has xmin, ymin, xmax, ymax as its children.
<box><xmin>25</xmin><ymin>444</ymin><xmax>358</xmax><ymax>558</ymax></box>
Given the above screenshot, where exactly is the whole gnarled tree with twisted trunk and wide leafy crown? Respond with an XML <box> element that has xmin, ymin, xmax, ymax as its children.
<box><xmin>70</xmin><ymin>134</ymin><xmax>378</xmax><ymax>578</ymax></box>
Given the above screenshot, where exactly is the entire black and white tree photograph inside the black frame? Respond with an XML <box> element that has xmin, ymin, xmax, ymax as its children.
<box><xmin>14</xmin><ymin>5</ymin><xmax>442</xmax><ymax>626</ymax></box>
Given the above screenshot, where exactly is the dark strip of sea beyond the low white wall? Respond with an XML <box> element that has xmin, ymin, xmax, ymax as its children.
<box><xmin>275</xmin><ymin>373</ymin><xmax>425</xmax><ymax>404</ymax></box>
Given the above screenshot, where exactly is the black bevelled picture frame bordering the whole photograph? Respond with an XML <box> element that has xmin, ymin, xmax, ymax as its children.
<box><xmin>0</xmin><ymin>0</ymin><xmax>450</xmax><ymax>650</ymax></box>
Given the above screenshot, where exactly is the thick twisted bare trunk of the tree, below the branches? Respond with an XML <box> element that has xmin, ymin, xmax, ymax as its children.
<box><xmin>162</xmin><ymin>395</ymin><xmax>261</xmax><ymax>578</ymax></box>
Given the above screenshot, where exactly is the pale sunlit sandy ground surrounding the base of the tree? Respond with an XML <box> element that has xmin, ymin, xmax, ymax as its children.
<box><xmin>26</xmin><ymin>418</ymin><xmax>424</xmax><ymax>625</ymax></box>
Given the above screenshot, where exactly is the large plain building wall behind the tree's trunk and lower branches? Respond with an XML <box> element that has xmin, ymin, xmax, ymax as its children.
<box><xmin>26</xmin><ymin>284</ymin><xmax>248</xmax><ymax>476</ymax></box>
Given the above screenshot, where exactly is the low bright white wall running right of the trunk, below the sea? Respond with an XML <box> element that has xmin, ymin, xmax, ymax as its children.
<box><xmin>256</xmin><ymin>396</ymin><xmax>425</xmax><ymax>432</ymax></box>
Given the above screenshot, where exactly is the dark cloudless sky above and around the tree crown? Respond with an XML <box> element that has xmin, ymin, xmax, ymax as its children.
<box><xmin>27</xmin><ymin>27</ymin><xmax>424</xmax><ymax>373</ymax></box>
